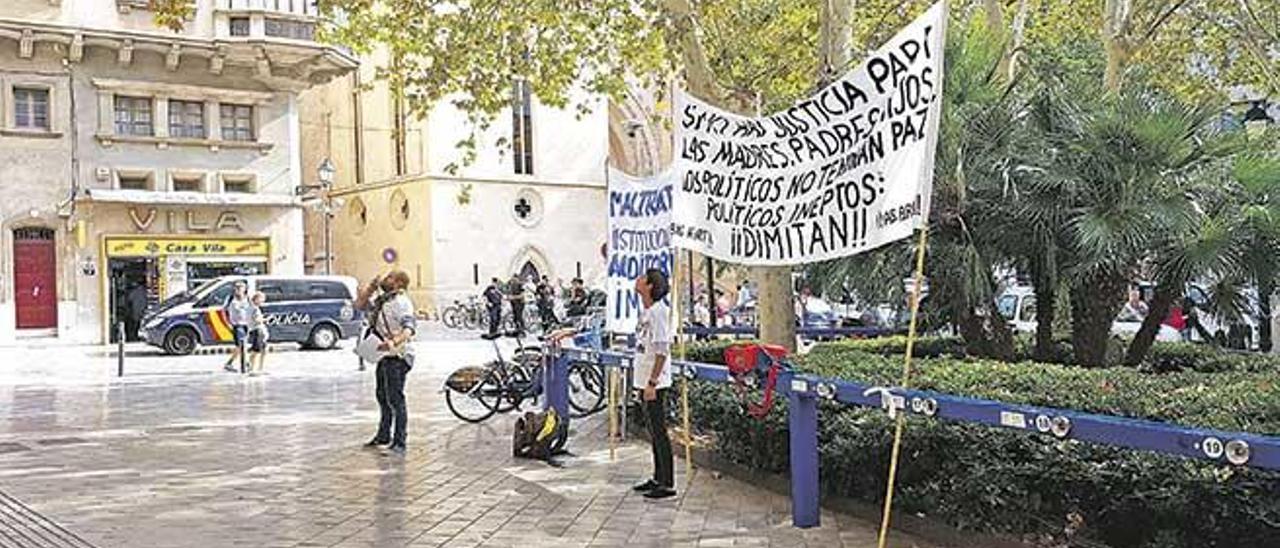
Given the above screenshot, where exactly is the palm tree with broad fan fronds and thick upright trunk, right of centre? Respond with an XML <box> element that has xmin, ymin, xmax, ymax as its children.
<box><xmin>1039</xmin><ymin>87</ymin><xmax>1211</xmax><ymax>365</ymax></box>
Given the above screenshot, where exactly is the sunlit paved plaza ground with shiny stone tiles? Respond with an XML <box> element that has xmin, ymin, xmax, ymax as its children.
<box><xmin>0</xmin><ymin>337</ymin><xmax>932</xmax><ymax>548</ymax></box>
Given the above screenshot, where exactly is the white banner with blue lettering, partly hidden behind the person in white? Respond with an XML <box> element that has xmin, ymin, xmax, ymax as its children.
<box><xmin>604</xmin><ymin>168</ymin><xmax>676</xmax><ymax>334</ymax></box>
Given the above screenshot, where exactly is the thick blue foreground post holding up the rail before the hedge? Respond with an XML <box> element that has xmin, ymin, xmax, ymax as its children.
<box><xmin>787</xmin><ymin>379</ymin><xmax>820</xmax><ymax>529</ymax></box>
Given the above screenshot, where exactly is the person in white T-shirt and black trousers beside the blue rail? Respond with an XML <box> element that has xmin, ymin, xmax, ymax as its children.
<box><xmin>632</xmin><ymin>269</ymin><xmax>676</xmax><ymax>499</ymax></box>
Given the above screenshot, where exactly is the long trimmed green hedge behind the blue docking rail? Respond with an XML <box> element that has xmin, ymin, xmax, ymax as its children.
<box><xmin>670</xmin><ymin>342</ymin><xmax>1280</xmax><ymax>548</ymax></box>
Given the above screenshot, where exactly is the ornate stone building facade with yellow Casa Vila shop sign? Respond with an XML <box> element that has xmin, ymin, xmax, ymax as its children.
<box><xmin>0</xmin><ymin>0</ymin><xmax>356</xmax><ymax>343</ymax></box>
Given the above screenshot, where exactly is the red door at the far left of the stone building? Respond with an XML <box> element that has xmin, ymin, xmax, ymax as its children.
<box><xmin>13</xmin><ymin>228</ymin><xmax>58</xmax><ymax>329</ymax></box>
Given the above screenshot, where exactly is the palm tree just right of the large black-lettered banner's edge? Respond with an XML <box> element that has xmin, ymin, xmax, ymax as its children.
<box><xmin>928</xmin><ymin>20</ymin><xmax>1025</xmax><ymax>359</ymax></box>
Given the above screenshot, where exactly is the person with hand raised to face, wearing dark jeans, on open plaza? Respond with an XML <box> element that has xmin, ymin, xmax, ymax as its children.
<box><xmin>356</xmin><ymin>270</ymin><xmax>417</xmax><ymax>456</ymax></box>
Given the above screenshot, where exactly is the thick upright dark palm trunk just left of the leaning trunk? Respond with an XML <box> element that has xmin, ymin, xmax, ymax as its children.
<box><xmin>1071</xmin><ymin>273</ymin><xmax>1126</xmax><ymax>366</ymax></box>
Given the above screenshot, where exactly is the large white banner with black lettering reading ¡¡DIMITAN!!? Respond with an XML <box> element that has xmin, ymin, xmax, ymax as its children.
<box><xmin>672</xmin><ymin>1</ymin><xmax>946</xmax><ymax>265</ymax></box>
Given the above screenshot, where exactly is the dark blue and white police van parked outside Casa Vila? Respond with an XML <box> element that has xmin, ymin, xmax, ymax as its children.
<box><xmin>142</xmin><ymin>275</ymin><xmax>364</xmax><ymax>356</ymax></box>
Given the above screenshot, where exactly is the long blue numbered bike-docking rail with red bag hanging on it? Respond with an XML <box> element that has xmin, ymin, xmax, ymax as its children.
<box><xmin>547</xmin><ymin>337</ymin><xmax>1280</xmax><ymax>528</ymax></box>
